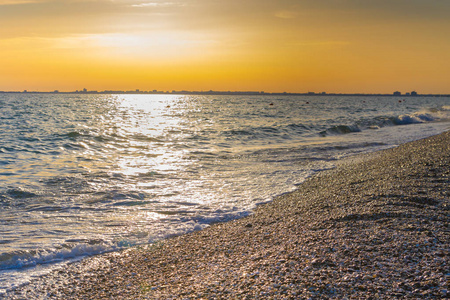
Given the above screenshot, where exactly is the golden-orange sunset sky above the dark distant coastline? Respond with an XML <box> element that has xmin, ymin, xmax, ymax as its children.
<box><xmin>0</xmin><ymin>0</ymin><xmax>450</xmax><ymax>94</ymax></box>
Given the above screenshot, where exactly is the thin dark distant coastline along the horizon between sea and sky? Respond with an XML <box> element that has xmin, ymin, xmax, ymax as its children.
<box><xmin>0</xmin><ymin>90</ymin><xmax>450</xmax><ymax>98</ymax></box>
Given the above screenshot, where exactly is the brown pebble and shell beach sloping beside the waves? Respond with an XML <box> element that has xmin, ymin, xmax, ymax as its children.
<box><xmin>6</xmin><ymin>131</ymin><xmax>450</xmax><ymax>299</ymax></box>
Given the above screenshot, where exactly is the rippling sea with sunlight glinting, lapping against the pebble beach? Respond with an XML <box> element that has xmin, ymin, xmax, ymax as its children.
<box><xmin>0</xmin><ymin>94</ymin><xmax>450</xmax><ymax>295</ymax></box>
